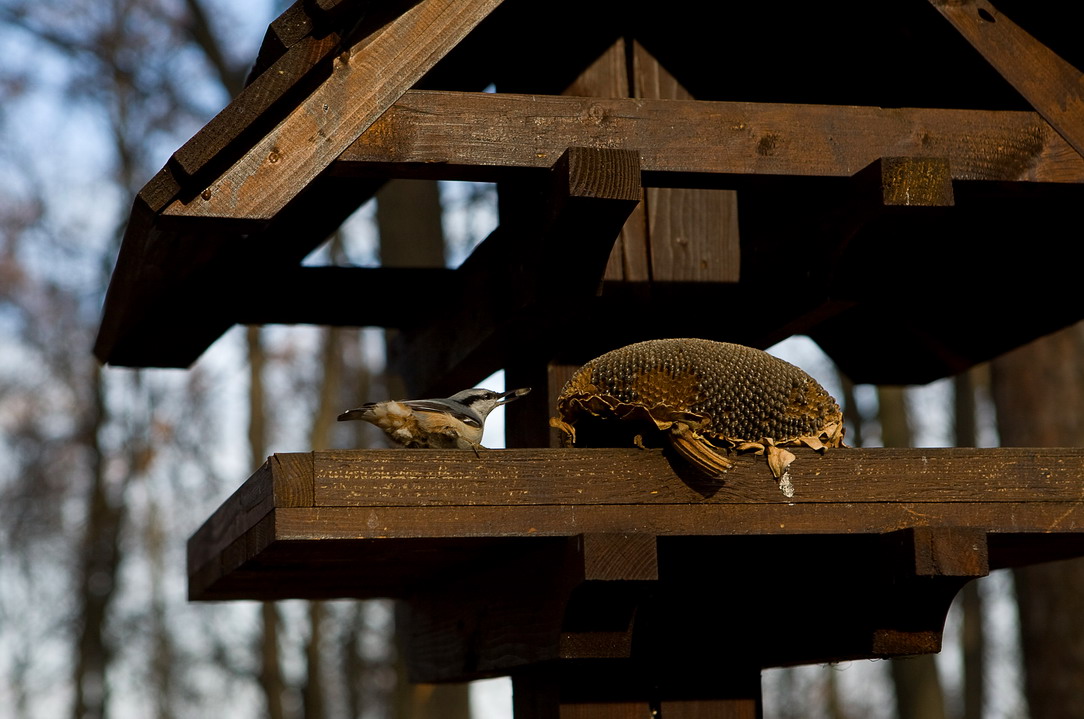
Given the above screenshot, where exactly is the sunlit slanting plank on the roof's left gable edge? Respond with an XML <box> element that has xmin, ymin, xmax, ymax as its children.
<box><xmin>164</xmin><ymin>0</ymin><xmax>501</xmax><ymax>220</ymax></box>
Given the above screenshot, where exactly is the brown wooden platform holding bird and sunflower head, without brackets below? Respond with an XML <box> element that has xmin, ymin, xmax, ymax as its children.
<box><xmin>189</xmin><ymin>448</ymin><xmax>1084</xmax><ymax>600</ymax></box>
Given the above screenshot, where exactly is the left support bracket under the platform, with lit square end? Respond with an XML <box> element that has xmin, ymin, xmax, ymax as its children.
<box><xmin>410</xmin><ymin>535</ymin><xmax>658</xmax><ymax>681</ymax></box>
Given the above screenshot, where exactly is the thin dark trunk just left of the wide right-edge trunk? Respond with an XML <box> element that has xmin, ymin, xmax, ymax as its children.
<box><xmin>953</xmin><ymin>368</ymin><xmax>986</xmax><ymax>719</ymax></box>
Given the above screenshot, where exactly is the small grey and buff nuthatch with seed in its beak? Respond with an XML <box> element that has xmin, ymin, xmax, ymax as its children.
<box><xmin>338</xmin><ymin>387</ymin><xmax>531</xmax><ymax>454</ymax></box>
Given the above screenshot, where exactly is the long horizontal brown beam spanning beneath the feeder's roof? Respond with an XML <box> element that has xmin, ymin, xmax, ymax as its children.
<box><xmin>334</xmin><ymin>91</ymin><xmax>1084</xmax><ymax>187</ymax></box>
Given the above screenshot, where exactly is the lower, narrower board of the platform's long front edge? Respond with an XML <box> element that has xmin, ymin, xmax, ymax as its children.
<box><xmin>268</xmin><ymin>502</ymin><xmax>1084</xmax><ymax>542</ymax></box>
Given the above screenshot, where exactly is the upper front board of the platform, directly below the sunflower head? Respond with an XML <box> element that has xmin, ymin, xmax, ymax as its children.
<box><xmin>305</xmin><ymin>448</ymin><xmax>1084</xmax><ymax>505</ymax></box>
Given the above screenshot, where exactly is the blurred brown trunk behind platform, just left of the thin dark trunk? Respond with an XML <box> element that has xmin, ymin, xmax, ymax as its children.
<box><xmin>877</xmin><ymin>387</ymin><xmax>945</xmax><ymax>719</ymax></box>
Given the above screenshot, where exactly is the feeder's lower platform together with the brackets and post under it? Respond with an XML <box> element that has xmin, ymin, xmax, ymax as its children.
<box><xmin>189</xmin><ymin>448</ymin><xmax>1084</xmax><ymax>689</ymax></box>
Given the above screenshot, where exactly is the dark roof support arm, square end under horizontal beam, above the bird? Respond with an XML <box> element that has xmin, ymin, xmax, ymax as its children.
<box><xmin>395</xmin><ymin>147</ymin><xmax>641</xmax><ymax>396</ymax></box>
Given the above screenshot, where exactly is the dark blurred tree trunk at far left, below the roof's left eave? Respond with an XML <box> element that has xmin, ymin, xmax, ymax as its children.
<box><xmin>72</xmin><ymin>360</ymin><xmax>125</xmax><ymax>719</ymax></box>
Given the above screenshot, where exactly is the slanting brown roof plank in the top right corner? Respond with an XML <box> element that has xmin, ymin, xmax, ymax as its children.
<box><xmin>930</xmin><ymin>0</ymin><xmax>1084</xmax><ymax>155</ymax></box>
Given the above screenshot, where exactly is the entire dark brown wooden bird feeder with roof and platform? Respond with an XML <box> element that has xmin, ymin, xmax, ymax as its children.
<box><xmin>95</xmin><ymin>0</ymin><xmax>1084</xmax><ymax>719</ymax></box>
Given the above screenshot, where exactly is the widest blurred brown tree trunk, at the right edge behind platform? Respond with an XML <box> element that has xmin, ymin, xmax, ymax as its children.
<box><xmin>992</xmin><ymin>323</ymin><xmax>1084</xmax><ymax>719</ymax></box>
